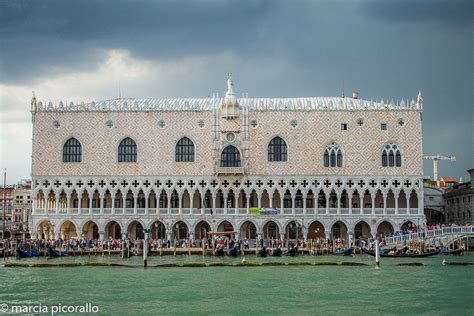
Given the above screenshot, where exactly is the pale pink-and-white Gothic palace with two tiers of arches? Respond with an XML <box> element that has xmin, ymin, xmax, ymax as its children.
<box><xmin>31</xmin><ymin>76</ymin><xmax>425</xmax><ymax>242</ymax></box>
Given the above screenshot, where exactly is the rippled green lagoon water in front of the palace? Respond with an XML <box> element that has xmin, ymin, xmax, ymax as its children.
<box><xmin>0</xmin><ymin>254</ymin><xmax>474</xmax><ymax>315</ymax></box>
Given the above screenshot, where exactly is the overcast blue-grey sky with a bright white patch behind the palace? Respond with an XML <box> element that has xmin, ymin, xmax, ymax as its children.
<box><xmin>0</xmin><ymin>0</ymin><xmax>474</xmax><ymax>183</ymax></box>
